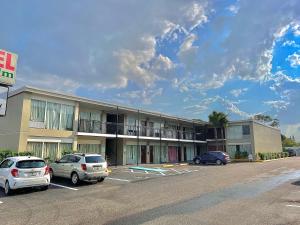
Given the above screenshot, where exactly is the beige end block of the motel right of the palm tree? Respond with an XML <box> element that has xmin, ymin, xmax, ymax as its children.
<box><xmin>226</xmin><ymin>119</ymin><xmax>282</xmax><ymax>158</ymax></box>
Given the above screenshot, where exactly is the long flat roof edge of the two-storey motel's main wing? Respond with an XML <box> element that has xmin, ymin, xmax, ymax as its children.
<box><xmin>9</xmin><ymin>86</ymin><xmax>209</xmax><ymax>125</ymax></box>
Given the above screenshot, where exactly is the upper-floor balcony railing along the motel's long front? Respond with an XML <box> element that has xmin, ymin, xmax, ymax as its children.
<box><xmin>78</xmin><ymin>119</ymin><xmax>205</xmax><ymax>140</ymax></box>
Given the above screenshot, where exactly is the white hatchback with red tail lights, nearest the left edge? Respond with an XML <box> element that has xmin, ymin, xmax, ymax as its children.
<box><xmin>0</xmin><ymin>156</ymin><xmax>50</xmax><ymax>195</ymax></box>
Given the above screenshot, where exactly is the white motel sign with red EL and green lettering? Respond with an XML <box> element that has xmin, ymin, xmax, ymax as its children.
<box><xmin>0</xmin><ymin>49</ymin><xmax>18</xmax><ymax>86</ymax></box>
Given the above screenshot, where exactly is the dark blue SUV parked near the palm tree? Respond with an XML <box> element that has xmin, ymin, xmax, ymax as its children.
<box><xmin>193</xmin><ymin>151</ymin><xmax>230</xmax><ymax>165</ymax></box>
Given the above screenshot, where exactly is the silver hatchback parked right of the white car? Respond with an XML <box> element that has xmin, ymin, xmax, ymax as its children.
<box><xmin>50</xmin><ymin>153</ymin><xmax>108</xmax><ymax>185</ymax></box>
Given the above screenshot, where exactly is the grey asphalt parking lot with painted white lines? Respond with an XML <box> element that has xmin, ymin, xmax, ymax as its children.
<box><xmin>0</xmin><ymin>158</ymin><xmax>300</xmax><ymax>225</ymax></box>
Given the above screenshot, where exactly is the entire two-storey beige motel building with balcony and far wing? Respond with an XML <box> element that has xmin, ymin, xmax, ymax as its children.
<box><xmin>0</xmin><ymin>87</ymin><xmax>282</xmax><ymax>165</ymax></box>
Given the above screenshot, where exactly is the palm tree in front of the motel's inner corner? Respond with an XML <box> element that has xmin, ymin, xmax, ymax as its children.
<box><xmin>208</xmin><ymin>111</ymin><xmax>228</xmax><ymax>150</ymax></box>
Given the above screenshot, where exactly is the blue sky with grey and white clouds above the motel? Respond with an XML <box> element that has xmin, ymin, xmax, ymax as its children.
<box><xmin>0</xmin><ymin>0</ymin><xmax>300</xmax><ymax>141</ymax></box>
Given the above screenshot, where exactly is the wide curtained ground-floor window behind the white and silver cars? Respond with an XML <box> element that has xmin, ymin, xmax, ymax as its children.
<box><xmin>27</xmin><ymin>142</ymin><xmax>73</xmax><ymax>161</ymax></box>
